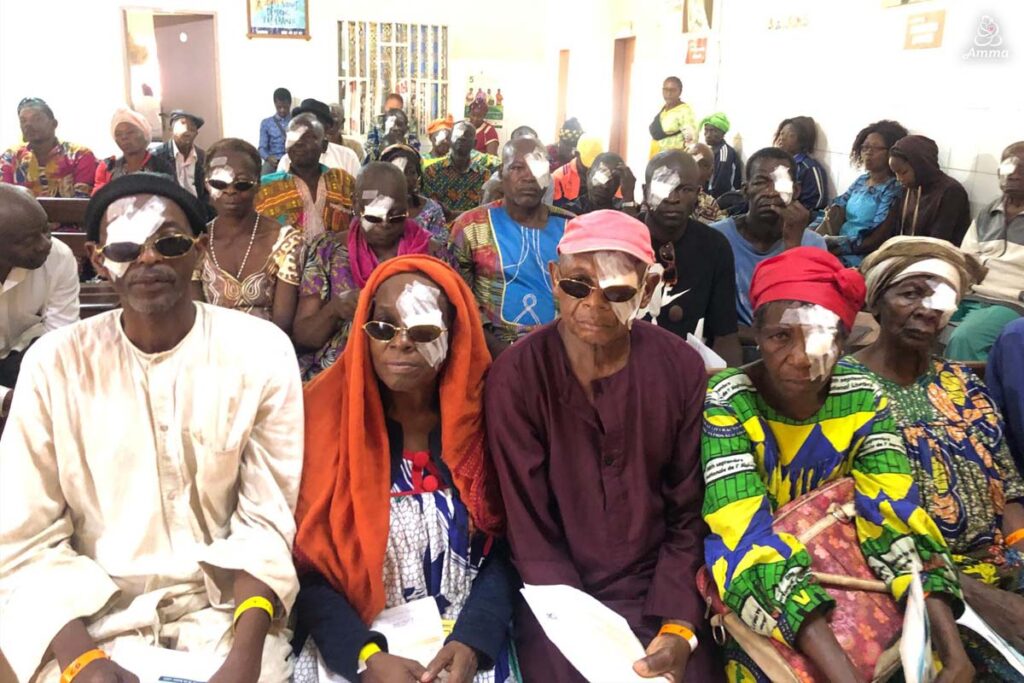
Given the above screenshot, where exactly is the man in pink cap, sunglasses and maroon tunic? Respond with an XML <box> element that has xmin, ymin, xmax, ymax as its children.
<box><xmin>484</xmin><ymin>211</ymin><xmax>721</xmax><ymax>683</ymax></box>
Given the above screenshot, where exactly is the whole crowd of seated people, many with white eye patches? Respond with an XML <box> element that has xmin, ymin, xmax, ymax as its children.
<box><xmin>0</xmin><ymin>77</ymin><xmax>1024</xmax><ymax>683</ymax></box>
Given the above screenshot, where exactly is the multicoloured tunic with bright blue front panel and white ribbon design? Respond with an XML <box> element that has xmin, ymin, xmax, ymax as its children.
<box><xmin>452</xmin><ymin>202</ymin><xmax>572</xmax><ymax>344</ymax></box>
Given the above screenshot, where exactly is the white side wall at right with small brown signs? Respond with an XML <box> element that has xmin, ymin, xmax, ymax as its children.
<box><xmin>547</xmin><ymin>0</ymin><xmax>1024</xmax><ymax>214</ymax></box>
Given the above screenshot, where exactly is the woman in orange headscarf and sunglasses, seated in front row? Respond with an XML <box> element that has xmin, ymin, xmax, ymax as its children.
<box><xmin>295</xmin><ymin>256</ymin><xmax>514</xmax><ymax>683</ymax></box>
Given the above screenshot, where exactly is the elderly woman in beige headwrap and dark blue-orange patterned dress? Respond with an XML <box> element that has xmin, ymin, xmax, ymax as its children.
<box><xmin>843</xmin><ymin>238</ymin><xmax>1024</xmax><ymax>681</ymax></box>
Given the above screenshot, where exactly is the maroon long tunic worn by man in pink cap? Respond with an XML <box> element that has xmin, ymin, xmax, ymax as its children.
<box><xmin>485</xmin><ymin>323</ymin><xmax>722</xmax><ymax>683</ymax></box>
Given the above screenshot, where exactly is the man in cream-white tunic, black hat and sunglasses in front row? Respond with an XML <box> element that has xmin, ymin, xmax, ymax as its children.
<box><xmin>0</xmin><ymin>173</ymin><xmax>303</xmax><ymax>683</ymax></box>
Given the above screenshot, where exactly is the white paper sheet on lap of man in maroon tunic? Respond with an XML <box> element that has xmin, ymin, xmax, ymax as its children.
<box><xmin>522</xmin><ymin>585</ymin><xmax>666</xmax><ymax>683</ymax></box>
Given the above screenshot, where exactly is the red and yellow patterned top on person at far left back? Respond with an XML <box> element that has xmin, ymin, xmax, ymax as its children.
<box><xmin>0</xmin><ymin>141</ymin><xmax>96</xmax><ymax>197</ymax></box>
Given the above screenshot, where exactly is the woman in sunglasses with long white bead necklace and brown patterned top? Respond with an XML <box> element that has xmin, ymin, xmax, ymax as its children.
<box><xmin>193</xmin><ymin>137</ymin><xmax>304</xmax><ymax>335</ymax></box>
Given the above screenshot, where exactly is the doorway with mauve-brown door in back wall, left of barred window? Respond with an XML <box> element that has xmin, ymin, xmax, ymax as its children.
<box><xmin>125</xmin><ymin>9</ymin><xmax>222</xmax><ymax>147</ymax></box>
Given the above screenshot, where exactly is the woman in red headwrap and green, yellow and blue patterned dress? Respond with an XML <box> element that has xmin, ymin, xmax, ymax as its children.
<box><xmin>701</xmin><ymin>247</ymin><xmax>973</xmax><ymax>681</ymax></box>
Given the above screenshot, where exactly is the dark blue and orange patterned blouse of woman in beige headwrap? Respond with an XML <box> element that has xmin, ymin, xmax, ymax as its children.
<box><xmin>842</xmin><ymin>357</ymin><xmax>1024</xmax><ymax>566</ymax></box>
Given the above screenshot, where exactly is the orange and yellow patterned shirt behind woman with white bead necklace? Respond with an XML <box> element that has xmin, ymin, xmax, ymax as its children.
<box><xmin>256</xmin><ymin>164</ymin><xmax>355</xmax><ymax>241</ymax></box>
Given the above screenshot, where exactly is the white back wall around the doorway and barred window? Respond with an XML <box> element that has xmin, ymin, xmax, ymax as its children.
<box><xmin>0</xmin><ymin>0</ymin><xmax>555</xmax><ymax>155</ymax></box>
